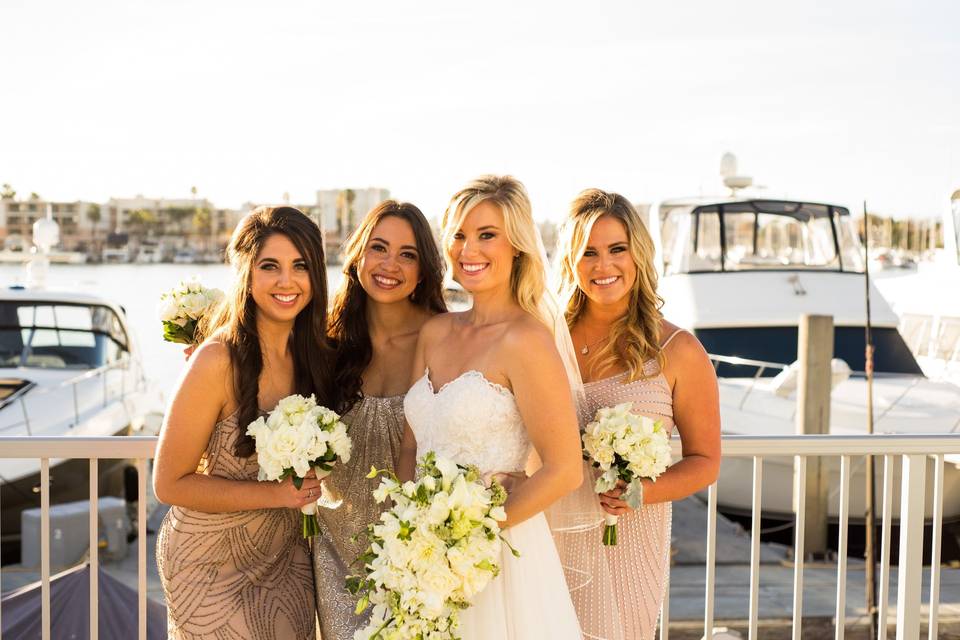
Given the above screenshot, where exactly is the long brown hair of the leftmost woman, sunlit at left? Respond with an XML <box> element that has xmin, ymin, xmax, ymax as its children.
<box><xmin>203</xmin><ymin>207</ymin><xmax>334</xmax><ymax>458</ymax></box>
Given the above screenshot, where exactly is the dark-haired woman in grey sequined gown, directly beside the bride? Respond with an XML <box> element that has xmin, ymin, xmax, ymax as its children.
<box><xmin>313</xmin><ymin>200</ymin><xmax>446</xmax><ymax>640</ymax></box>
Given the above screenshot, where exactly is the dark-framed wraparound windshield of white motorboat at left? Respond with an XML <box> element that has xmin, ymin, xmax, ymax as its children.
<box><xmin>0</xmin><ymin>300</ymin><xmax>129</xmax><ymax>369</ymax></box>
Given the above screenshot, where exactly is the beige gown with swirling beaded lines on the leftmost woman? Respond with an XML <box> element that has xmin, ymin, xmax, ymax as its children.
<box><xmin>157</xmin><ymin>414</ymin><xmax>316</xmax><ymax>640</ymax></box>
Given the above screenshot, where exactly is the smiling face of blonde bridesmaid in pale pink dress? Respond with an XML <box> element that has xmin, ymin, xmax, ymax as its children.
<box><xmin>577</xmin><ymin>215</ymin><xmax>637</xmax><ymax>306</ymax></box>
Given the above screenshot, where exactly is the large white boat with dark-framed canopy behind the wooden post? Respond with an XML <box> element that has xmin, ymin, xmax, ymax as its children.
<box><xmin>649</xmin><ymin>197</ymin><xmax>960</xmax><ymax>521</ymax></box>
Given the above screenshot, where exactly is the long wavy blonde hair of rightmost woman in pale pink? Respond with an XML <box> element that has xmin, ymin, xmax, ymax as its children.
<box><xmin>557</xmin><ymin>189</ymin><xmax>664</xmax><ymax>381</ymax></box>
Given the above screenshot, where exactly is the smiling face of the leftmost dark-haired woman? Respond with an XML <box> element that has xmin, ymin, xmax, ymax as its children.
<box><xmin>250</xmin><ymin>233</ymin><xmax>313</xmax><ymax>322</ymax></box>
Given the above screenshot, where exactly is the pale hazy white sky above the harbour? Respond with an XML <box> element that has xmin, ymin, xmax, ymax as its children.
<box><xmin>0</xmin><ymin>0</ymin><xmax>960</xmax><ymax>218</ymax></box>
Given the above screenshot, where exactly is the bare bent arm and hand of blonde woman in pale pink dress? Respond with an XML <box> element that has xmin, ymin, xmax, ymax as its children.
<box><xmin>600</xmin><ymin>332</ymin><xmax>720</xmax><ymax>515</ymax></box>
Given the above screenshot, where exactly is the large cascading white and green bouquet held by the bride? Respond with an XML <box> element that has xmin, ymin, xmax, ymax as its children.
<box><xmin>347</xmin><ymin>451</ymin><xmax>519</xmax><ymax>640</ymax></box>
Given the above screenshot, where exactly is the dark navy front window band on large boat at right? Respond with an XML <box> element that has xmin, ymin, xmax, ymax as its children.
<box><xmin>694</xmin><ymin>326</ymin><xmax>922</xmax><ymax>377</ymax></box>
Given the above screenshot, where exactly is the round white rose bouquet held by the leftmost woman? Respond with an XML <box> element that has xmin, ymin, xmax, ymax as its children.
<box><xmin>247</xmin><ymin>395</ymin><xmax>352</xmax><ymax>538</ymax></box>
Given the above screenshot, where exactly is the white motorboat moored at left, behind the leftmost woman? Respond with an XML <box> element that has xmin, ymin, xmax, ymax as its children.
<box><xmin>0</xmin><ymin>219</ymin><xmax>163</xmax><ymax>559</ymax></box>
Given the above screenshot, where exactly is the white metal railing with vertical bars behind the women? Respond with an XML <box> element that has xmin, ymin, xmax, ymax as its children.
<box><xmin>0</xmin><ymin>434</ymin><xmax>960</xmax><ymax>640</ymax></box>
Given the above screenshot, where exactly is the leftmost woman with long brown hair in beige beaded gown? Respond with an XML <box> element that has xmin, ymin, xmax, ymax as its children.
<box><xmin>153</xmin><ymin>207</ymin><xmax>334</xmax><ymax>640</ymax></box>
